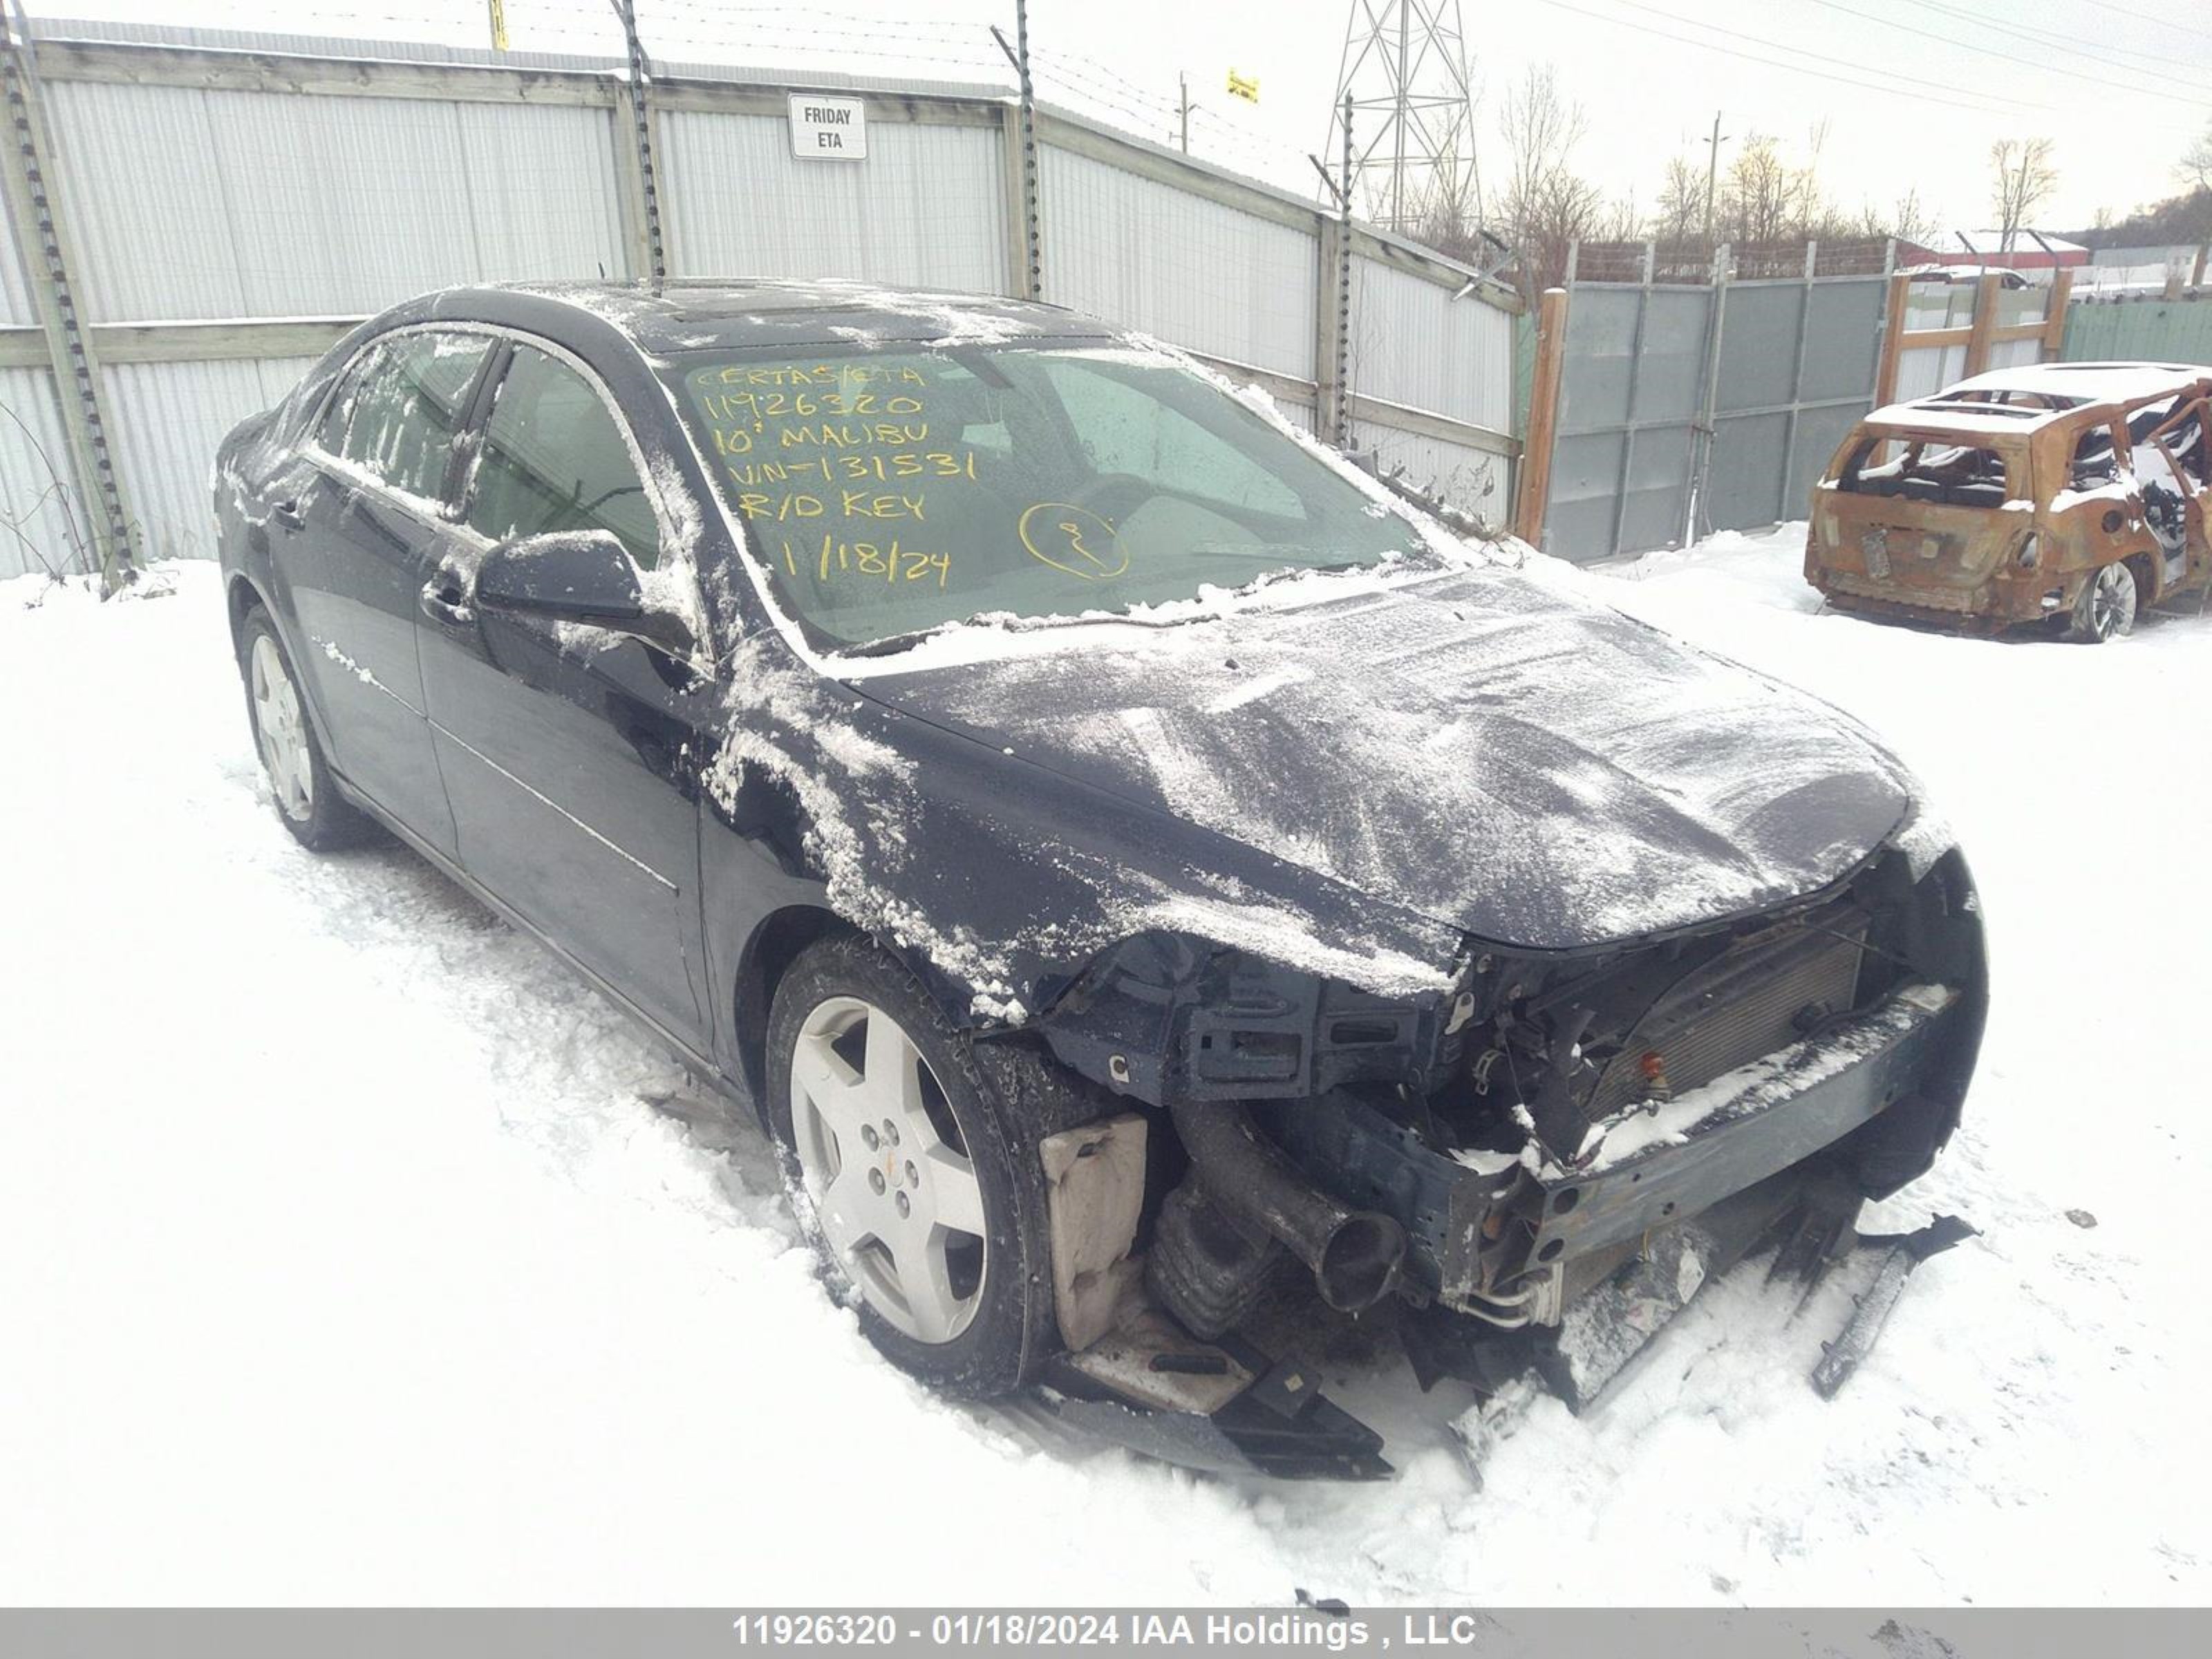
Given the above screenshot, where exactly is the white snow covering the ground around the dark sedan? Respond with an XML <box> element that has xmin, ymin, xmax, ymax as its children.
<box><xmin>0</xmin><ymin>529</ymin><xmax>2212</xmax><ymax>1604</ymax></box>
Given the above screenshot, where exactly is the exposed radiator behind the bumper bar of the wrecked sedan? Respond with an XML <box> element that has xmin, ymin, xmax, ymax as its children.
<box><xmin>1582</xmin><ymin>909</ymin><xmax>1867</xmax><ymax>1121</ymax></box>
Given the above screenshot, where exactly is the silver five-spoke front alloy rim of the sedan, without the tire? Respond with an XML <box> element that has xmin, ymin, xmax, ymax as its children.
<box><xmin>792</xmin><ymin>997</ymin><xmax>988</xmax><ymax>1342</ymax></box>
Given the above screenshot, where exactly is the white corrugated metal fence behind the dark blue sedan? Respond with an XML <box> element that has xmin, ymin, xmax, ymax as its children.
<box><xmin>0</xmin><ymin>24</ymin><xmax>1515</xmax><ymax>573</ymax></box>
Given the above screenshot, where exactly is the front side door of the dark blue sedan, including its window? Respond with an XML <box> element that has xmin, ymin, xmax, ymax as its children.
<box><xmin>418</xmin><ymin>345</ymin><xmax>706</xmax><ymax>1049</ymax></box>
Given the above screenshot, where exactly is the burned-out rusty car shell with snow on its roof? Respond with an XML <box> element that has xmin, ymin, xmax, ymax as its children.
<box><xmin>1805</xmin><ymin>363</ymin><xmax>2212</xmax><ymax>632</ymax></box>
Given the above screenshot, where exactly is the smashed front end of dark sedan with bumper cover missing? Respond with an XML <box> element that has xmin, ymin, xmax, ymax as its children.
<box><xmin>1004</xmin><ymin>843</ymin><xmax>1987</xmax><ymax>1478</ymax></box>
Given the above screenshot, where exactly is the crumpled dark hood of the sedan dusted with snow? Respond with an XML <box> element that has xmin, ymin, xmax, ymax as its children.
<box><xmin>856</xmin><ymin>568</ymin><xmax>1911</xmax><ymax>949</ymax></box>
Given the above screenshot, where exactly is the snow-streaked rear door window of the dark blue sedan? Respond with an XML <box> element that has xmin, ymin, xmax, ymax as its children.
<box><xmin>319</xmin><ymin>332</ymin><xmax>491</xmax><ymax>502</ymax></box>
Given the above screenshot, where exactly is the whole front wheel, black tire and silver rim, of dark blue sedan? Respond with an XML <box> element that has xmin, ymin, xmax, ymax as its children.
<box><xmin>767</xmin><ymin>938</ymin><xmax>1053</xmax><ymax>1398</ymax></box>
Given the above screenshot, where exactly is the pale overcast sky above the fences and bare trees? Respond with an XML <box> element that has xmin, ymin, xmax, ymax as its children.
<box><xmin>33</xmin><ymin>0</ymin><xmax>2212</xmax><ymax>230</ymax></box>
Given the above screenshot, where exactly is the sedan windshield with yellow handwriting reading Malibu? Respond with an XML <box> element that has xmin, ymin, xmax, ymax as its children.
<box><xmin>679</xmin><ymin>347</ymin><xmax>1418</xmax><ymax>648</ymax></box>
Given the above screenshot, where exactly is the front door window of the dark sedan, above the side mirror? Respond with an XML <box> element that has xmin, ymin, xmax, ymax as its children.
<box><xmin>469</xmin><ymin>345</ymin><xmax>662</xmax><ymax>568</ymax></box>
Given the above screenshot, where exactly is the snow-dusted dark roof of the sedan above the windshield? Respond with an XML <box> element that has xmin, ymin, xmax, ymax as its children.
<box><xmin>433</xmin><ymin>276</ymin><xmax>1124</xmax><ymax>358</ymax></box>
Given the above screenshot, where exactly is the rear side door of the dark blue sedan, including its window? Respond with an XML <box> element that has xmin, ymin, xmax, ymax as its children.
<box><xmin>283</xmin><ymin>330</ymin><xmax>491</xmax><ymax>854</ymax></box>
